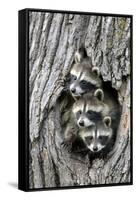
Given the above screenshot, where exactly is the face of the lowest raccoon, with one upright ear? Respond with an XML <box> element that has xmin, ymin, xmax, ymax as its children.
<box><xmin>79</xmin><ymin>116</ymin><xmax>113</xmax><ymax>153</ymax></box>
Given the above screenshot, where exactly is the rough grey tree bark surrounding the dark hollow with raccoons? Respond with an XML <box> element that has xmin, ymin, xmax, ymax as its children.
<box><xmin>29</xmin><ymin>12</ymin><xmax>131</xmax><ymax>188</ymax></box>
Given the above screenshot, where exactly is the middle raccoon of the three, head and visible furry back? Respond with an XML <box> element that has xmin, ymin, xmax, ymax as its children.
<box><xmin>72</xmin><ymin>89</ymin><xmax>120</xmax><ymax>128</ymax></box>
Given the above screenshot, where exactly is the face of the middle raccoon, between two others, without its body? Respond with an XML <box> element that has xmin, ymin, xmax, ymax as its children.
<box><xmin>73</xmin><ymin>89</ymin><xmax>108</xmax><ymax>128</ymax></box>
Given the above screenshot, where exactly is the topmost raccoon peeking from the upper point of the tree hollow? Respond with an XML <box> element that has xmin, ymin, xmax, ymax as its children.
<box><xmin>70</xmin><ymin>48</ymin><xmax>102</xmax><ymax>99</ymax></box>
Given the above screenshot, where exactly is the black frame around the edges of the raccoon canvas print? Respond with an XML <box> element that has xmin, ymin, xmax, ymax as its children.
<box><xmin>18</xmin><ymin>8</ymin><xmax>133</xmax><ymax>191</ymax></box>
